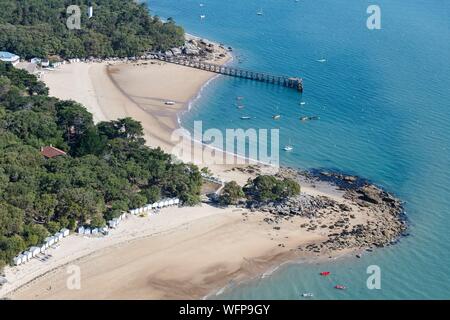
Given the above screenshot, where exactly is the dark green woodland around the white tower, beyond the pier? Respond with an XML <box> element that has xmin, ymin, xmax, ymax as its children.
<box><xmin>0</xmin><ymin>0</ymin><xmax>184</xmax><ymax>59</ymax></box>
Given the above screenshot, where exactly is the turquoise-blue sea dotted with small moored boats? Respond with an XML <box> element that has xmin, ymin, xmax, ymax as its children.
<box><xmin>148</xmin><ymin>0</ymin><xmax>450</xmax><ymax>299</ymax></box>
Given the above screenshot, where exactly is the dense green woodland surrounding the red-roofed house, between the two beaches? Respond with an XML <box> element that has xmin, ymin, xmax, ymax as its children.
<box><xmin>0</xmin><ymin>62</ymin><xmax>202</xmax><ymax>265</ymax></box>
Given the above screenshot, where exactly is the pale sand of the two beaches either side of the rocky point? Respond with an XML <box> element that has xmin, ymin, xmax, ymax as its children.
<box><xmin>0</xmin><ymin>43</ymin><xmax>394</xmax><ymax>299</ymax></box>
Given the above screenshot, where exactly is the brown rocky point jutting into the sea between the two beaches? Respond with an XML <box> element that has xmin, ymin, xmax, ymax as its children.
<box><xmin>230</xmin><ymin>168</ymin><xmax>407</xmax><ymax>257</ymax></box>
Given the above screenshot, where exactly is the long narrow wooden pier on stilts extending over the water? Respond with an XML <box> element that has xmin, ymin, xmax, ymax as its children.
<box><xmin>154</xmin><ymin>55</ymin><xmax>303</xmax><ymax>92</ymax></box>
